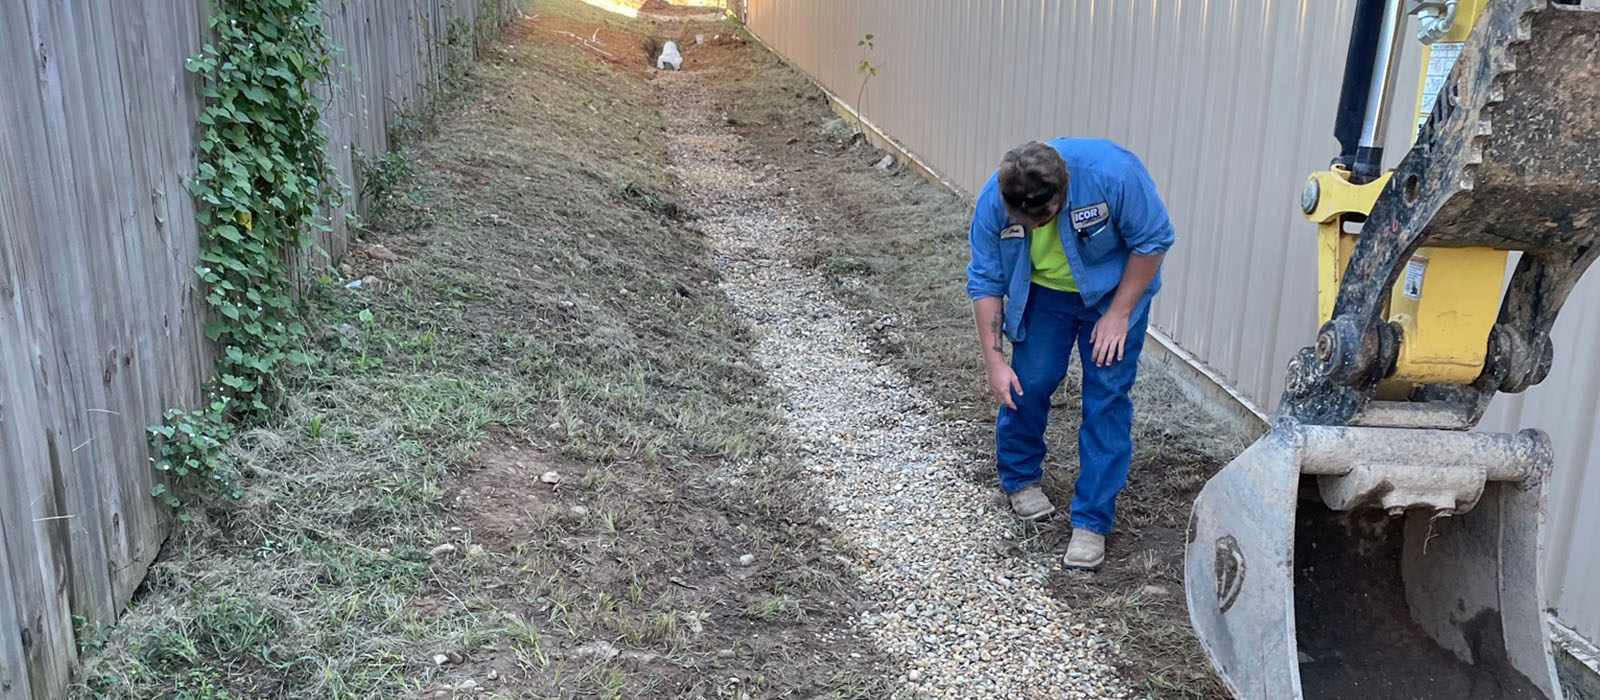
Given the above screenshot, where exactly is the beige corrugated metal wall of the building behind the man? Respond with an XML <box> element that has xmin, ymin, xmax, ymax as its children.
<box><xmin>747</xmin><ymin>0</ymin><xmax>1600</xmax><ymax>639</ymax></box>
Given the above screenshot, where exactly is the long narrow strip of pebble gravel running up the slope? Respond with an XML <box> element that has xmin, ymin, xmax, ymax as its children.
<box><xmin>656</xmin><ymin>72</ymin><xmax>1130</xmax><ymax>698</ymax></box>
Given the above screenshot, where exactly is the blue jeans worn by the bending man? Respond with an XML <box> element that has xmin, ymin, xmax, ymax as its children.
<box><xmin>995</xmin><ymin>284</ymin><xmax>1147</xmax><ymax>534</ymax></box>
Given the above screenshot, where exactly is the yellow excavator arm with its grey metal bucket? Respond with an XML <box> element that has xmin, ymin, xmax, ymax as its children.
<box><xmin>1184</xmin><ymin>0</ymin><xmax>1600</xmax><ymax>700</ymax></box>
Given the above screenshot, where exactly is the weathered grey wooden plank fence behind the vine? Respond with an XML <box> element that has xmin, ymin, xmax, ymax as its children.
<box><xmin>0</xmin><ymin>0</ymin><xmax>517</xmax><ymax>700</ymax></box>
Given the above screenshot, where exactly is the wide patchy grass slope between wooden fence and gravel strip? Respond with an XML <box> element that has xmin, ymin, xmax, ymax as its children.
<box><xmin>77</xmin><ymin>0</ymin><xmax>888</xmax><ymax>700</ymax></box>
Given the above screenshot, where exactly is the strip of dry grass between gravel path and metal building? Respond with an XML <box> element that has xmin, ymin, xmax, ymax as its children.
<box><xmin>720</xmin><ymin>36</ymin><xmax>1245</xmax><ymax>698</ymax></box>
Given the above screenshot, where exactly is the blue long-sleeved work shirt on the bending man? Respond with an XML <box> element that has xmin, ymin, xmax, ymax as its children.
<box><xmin>966</xmin><ymin>137</ymin><xmax>1174</xmax><ymax>342</ymax></box>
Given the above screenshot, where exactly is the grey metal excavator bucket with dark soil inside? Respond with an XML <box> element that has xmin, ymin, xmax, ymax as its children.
<box><xmin>1184</xmin><ymin>422</ymin><xmax>1562</xmax><ymax>700</ymax></box>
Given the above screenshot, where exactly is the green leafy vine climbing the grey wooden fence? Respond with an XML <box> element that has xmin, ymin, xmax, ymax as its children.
<box><xmin>150</xmin><ymin>0</ymin><xmax>341</xmax><ymax>507</ymax></box>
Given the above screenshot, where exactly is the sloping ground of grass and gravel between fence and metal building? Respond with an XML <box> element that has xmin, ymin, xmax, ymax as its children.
<box><xmin>77</xmin><ymin>0</ymin><xmax>1242</xmax><ymax>698</ymax></box>
